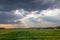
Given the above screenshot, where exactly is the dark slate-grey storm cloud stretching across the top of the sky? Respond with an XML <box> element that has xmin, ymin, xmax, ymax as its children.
<box><xmin>0</xmin><ymin>0</ymin><xmax>60</xmax><ymax>11</ymax></box>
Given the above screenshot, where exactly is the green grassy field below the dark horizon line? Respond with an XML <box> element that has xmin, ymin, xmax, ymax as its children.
<box><xmin>0</xmin><ymin>29</ymin><xmax>60</xmax><ymax>40</ymax></box>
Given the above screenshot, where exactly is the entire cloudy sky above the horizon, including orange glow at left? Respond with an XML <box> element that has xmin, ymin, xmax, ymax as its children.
<box><xmin>0</xmin><ymin>0</ymin><xmax>60</xmax><ymax>28</ymax></box>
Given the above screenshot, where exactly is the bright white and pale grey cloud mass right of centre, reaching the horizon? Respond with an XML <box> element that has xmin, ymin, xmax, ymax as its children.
<box><xmin>20</xmin><ymin>9</ymin><xmax>60</xmax><ymax>27</ymax></box>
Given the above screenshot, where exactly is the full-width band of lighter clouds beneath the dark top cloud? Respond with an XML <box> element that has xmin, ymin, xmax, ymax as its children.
<box><xmin>0</xmin><ymin>9</ymin><xmax>60</xmax><ymax>28</ymax></box>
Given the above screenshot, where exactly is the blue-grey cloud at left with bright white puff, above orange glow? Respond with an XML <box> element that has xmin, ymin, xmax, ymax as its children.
<box><xmin>0</xmin><ymin>9</ymin><xmax>29</xmax><ymax>24</ymax></box>
